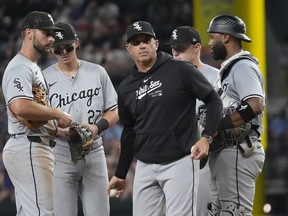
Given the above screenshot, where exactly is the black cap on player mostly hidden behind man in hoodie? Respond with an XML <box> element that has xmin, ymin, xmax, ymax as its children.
<box><xmin>166</xmin><ymin>26</ymin><xmax>201</xmax><ymax>46</ymax></box>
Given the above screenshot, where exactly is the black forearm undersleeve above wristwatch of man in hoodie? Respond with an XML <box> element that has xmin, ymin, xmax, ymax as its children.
<box><xmin>202</xmin><ymin>89</ymin><xmax>223</xmax><ymax>136</ymax></box>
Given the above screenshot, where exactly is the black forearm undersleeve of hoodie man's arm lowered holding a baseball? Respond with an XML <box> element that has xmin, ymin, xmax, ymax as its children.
<box><xmin>115</xmin><ymin>127</ymin><xmax>136</xmax><ymax>179</ymax></box>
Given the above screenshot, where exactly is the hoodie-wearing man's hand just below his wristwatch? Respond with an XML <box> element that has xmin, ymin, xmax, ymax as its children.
<box><xmin>190</xmin><ymin>137</ymin><xmax>209</xmax><ymax>160</ymax></box>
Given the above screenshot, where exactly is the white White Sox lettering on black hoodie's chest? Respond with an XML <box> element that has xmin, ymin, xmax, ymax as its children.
<box><xmin>136</xmin><ymin>80</ymin><xmax>162</xmax><ymax>100</ymax></box>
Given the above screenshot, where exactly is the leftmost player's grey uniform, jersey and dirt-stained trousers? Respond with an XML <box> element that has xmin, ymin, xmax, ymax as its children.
<box><xmin>2</xmin><ymin>54</ymin><xmax>57</xmax><ymax>216</ymax></box>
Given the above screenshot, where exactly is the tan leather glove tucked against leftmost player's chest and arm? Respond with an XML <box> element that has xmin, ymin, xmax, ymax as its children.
<box><xmin>9</xmin><ymin>86</ymin><xmax>48</xmax><ymax>132</ymax></box>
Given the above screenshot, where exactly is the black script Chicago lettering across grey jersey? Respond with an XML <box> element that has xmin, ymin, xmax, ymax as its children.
<box><xmin>50</xmin><ymin>87</ymin><xmax>101</xmax><ymax>108</ymax></box>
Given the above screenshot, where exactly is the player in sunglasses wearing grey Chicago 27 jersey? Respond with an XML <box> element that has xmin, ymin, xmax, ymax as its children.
<box><xmin>43</xmin><ymin>22</ymin><xmax>118</xmax><ymax>216</ymax></box>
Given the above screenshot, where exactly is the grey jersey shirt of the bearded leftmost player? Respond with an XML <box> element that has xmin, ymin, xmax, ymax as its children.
<box><xmin>2</xmin><ymin>54</ymin><xmax>56</xmax><ymax>136</ymax></box>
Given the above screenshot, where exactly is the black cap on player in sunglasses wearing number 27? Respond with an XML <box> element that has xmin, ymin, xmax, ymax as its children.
<box><xmin>53</xmin><ymin>22</ymin><xmax>78</xmax><ymax>47</ymax></box>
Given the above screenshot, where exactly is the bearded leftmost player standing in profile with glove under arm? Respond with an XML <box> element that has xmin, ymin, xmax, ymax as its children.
<box><xmin>2</xmin><ymin>11</ymin><xmax>72</xmax><ymax>216</ymax></box>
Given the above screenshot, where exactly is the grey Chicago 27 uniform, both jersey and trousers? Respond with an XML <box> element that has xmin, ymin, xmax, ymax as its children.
<box><xmin>43</xmin><ymin>60</ymin><xmax>117</xmax><ymax>216</ymax></box>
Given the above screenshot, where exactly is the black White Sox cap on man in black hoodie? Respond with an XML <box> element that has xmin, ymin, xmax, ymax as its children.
<box><xmin>126</xmin><ymin>21</ymin><xmax>156</xmax><ymax>42</ymax></box>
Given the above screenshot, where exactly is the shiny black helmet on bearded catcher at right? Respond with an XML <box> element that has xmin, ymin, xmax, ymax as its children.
<box><xmin>207</xmin><ymin>15</ymin><xmax>251</xmax><ymax>42</ymax></box>
